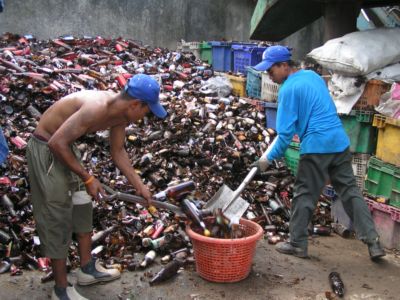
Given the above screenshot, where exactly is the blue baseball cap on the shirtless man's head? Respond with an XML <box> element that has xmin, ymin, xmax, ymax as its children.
<box><xmin>125</xmin><ymin>74</ymin><xmax>167</xmax><ymax>118</ymax></box>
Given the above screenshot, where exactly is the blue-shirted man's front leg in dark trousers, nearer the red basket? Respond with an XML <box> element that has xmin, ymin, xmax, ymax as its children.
<box><xmin>276</xmin><ymin>154</ymin><xmax>332</xmax><ymax>257</ymax></box>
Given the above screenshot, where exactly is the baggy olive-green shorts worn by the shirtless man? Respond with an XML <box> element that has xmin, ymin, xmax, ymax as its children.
<box><xmin>26</xmin><ymin>136</ymin><xmax>93</xmax><ymax>259</ymax></box>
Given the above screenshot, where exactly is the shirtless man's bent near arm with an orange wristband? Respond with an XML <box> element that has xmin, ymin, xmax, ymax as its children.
<box><xmin>48</xmin><ymin>106</ymin><xmax>104</xmax><ymax>199</ymax></box>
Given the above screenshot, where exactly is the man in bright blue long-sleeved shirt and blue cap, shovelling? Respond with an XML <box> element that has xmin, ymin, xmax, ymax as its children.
<box><xmin>255</xmin><ymin>46</ymin><xmax>385</xmax><ymax>259</ymax></box>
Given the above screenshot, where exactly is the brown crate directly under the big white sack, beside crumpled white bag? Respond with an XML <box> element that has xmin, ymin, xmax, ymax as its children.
<box><xmin>353</xmin><ymin>79</ymin><xmax>391</xmax><ymax>111</ymax></box>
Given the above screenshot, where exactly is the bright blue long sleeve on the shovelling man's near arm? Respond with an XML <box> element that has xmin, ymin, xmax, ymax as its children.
<box><xmin>267</xmin><ymin>85</ymin><xmax>299</xmax><ymax>161</ymax></box>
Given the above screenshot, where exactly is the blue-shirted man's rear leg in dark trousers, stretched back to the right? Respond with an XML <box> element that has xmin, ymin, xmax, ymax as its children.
<box><xmin>329</xmin><ymin>150</ymin><xmax>385</xmax><ymax>258</ymax></box>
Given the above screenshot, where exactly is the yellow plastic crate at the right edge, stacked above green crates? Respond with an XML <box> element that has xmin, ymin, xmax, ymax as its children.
<box><xmin>372</xmin><ymin>115</ymin><xmax>400</xmax><ymax>167</ymax></box>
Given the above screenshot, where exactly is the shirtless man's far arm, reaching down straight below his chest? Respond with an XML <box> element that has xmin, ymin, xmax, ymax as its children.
<box><xmin>110</xmin><ymin>125</ymin><xmax>152</xmax><ymax>204</ymax></box>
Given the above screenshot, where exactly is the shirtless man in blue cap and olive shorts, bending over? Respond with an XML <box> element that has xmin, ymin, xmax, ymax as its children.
<box><xmin>27</xmin><ymin>74</ymin><xmax>167</xmax><ymax>300</ymax></box>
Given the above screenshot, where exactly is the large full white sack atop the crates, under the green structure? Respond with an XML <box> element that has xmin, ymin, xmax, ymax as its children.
<box><xmin>307</xmin><ymin>28</ymin><xmax>400</xmax><ymax>76</ymax></box>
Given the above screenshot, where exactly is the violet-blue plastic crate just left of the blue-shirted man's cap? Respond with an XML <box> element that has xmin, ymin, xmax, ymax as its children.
<box><xmin>232</xmin><ymin>45</ymin><xmax>267</xmax><ymax>74</ymax></box>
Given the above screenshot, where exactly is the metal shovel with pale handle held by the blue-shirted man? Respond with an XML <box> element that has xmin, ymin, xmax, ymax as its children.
<box><xmin>204</xmin><ymin>150</ymin><xmax>268</xmax><ymax>223</ymax></box>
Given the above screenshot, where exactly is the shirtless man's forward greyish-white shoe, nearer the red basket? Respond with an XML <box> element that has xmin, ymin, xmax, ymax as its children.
<box><xmin>76</xmin><ymin>259</ymin><xmax>121</xmax><ymax>285</ymax></box>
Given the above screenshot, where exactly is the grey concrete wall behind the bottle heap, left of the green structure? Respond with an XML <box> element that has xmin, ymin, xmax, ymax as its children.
<box><xmin>0</xmin><ymin>0</ymin><xmax>256</xmax><ymax>49</ymax></box>
